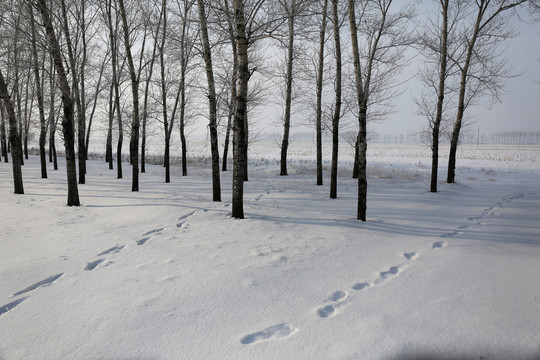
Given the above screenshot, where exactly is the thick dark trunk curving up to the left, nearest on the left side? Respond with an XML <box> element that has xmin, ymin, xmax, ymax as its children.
<box><xmin>37</xmin><ymin>0</ymin><xmax>80</xmax><ymax>206</ymax></box>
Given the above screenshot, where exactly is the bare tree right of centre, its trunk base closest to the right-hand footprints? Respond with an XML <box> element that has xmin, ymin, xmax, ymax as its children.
<box><xmin>348</xmin><ymin>0</ymin><xmax>414</xmax><ymax>221</ymax></box>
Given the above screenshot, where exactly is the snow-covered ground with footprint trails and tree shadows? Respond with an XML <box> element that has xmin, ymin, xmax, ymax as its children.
<box><xmin>0</xmin><ymin>143</ymin><xmax>540</xmax><ymax>360</ymax></box>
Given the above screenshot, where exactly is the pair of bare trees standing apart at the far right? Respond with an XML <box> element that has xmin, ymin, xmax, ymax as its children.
<box><xmin>417</xmin><ymin>0</ymin><xmax>537</xmax><ymax>192</ymax></box>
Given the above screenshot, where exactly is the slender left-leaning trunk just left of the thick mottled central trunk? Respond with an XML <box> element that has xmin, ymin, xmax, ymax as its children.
<box><xmin>197</xmin><ymin>0</ymin><xmax>221</xmax><ymax>201</ymax></box>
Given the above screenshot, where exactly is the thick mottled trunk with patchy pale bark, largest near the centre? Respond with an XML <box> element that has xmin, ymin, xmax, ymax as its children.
<box><xmin>232</xmin><ymin>0</ymin><xmax>249</xmax><ymax>219</ymax></box>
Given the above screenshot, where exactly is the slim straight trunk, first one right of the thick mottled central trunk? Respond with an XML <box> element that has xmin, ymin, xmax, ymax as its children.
<box><xmin>279</xmin><ymin>9</ymin><xmax>294</xmax><ymax>176</ymax></box>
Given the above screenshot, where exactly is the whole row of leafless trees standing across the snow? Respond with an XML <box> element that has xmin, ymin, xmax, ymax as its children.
<box><xmin>0</xmin><ymin>0</ymin><xmax>530</xmax><ymax>221</ymax></box>
